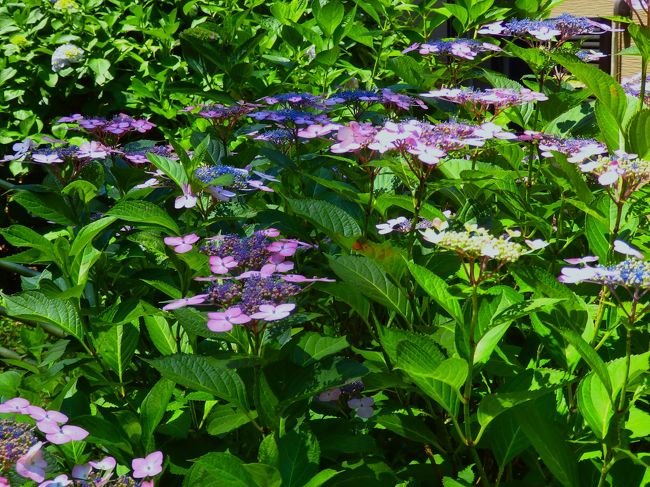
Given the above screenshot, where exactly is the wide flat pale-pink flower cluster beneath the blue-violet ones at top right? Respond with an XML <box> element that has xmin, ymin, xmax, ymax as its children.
<box><xmin>421</xmin><ymin>88</ymin><xmax>548</xmax><ymax>117</ymax></box>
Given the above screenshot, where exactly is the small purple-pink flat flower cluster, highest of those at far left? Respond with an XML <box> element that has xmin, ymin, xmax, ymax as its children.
<box><xmin>56</xmin><ymin>113</ymin><xmax>155</xmax><ymax>145</ymax></box>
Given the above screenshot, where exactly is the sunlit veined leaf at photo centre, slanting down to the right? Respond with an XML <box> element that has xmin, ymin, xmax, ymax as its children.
<box><xmin>327</xmin><ymin>255</ymin><xmax>411</xmax><ymax>320</ymax></box>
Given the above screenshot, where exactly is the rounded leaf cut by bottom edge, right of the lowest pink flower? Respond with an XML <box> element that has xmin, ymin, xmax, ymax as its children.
<box><xmin>183</xmin><ymin>452</ymin><xmax>257</xmax><ymax>487</ymax></box>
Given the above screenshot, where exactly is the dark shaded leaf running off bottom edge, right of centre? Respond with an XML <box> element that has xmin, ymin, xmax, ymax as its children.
<box><xmin>513</xmin><ymin>403</ymin><xmax>580</xmax><ymax>487</ymax></box>
